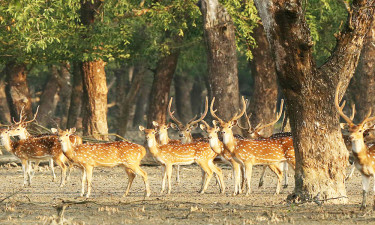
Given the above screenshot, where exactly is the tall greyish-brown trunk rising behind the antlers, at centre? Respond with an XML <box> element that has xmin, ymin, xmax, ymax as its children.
<box><xmin>201</xmin><ymin>0</ymin><xmax>240</xmax><ymax>132</ymax></box>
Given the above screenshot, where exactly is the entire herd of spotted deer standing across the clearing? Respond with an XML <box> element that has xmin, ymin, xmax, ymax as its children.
<box><xmin>0</xmin><ymin>82</ymin><xmax>375</xmax><ymax>208</ymax></box>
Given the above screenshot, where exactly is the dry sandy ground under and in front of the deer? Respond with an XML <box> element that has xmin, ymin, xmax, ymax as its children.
<box><xmin>0</xmin><ymin>159</ymin><xmax>375</xmax><ymax>224</ymax></box>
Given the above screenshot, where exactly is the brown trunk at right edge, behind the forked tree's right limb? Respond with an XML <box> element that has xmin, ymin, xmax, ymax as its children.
<box><xmin>348</xmin><ymin>17</ymin><xmax>375</xmax><ymax>121</ymax></box>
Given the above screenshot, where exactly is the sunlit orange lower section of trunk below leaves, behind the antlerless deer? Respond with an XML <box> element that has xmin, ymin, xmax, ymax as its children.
<box><xmin>82</xmin><ymin>60</ymin><xmax>108</xmax><ymax>140</ymax></box>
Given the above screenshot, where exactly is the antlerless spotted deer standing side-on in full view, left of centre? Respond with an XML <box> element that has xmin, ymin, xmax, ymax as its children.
<box><xmin>58</xmin><ymin>128</ymin><xmax>151</xmax><ymax>198</ymax></box>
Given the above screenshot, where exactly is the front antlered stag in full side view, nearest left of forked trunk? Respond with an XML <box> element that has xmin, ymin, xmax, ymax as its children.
<box><xmin>210</xmin><ymin>97</ymin><xmax>287</xmax><ymax>195</ymax></box>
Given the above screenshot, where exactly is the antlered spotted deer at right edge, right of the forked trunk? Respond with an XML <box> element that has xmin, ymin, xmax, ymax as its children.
<box><xmin>335</xmin><ymin>82</ymin><xmax>375</xmax><ymax>209</ymax></box>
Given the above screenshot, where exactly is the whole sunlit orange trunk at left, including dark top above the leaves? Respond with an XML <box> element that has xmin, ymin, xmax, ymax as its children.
<box><xmin>81</xmin><ymin>0</ymin><xmax>108</xmax><ymax>140</ymax></box>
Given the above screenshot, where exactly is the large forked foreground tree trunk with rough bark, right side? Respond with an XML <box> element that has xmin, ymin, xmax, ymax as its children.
<box><xmin>255</xmin><ymin>0</ymin><xmax>374</xmax><ymax>203</ymax></box>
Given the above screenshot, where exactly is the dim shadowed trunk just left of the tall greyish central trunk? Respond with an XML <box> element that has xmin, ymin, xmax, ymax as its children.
<box><xmin>174</xmin><ymin>72</ymin><xmax>193</xmax><ymax>123</ymax></box>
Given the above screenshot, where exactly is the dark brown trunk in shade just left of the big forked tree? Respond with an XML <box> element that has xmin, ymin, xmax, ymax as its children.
<box><xmin>250</xmin><ymin>24</ymin><xmax>277</xmax><ymax>136</ymax></box>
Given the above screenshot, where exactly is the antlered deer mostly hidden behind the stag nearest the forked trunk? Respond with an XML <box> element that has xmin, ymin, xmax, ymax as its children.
<box><xmin>237</xmin><ymin>99</ymin><xmax>295</xmax><ymax>188</ymax></box>
